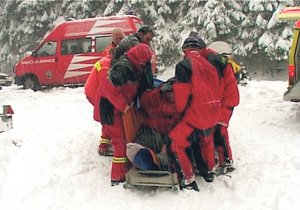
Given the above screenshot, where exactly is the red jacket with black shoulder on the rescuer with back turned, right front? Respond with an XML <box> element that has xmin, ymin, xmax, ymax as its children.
<box><xmin>173</xmin><ymin>50</ymin><xmax>221</xmax><ymax>129</ymax></box>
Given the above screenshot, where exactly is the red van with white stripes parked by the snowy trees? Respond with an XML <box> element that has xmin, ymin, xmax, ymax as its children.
<box><xmin>13</xmin><ymin>15</ymin><xmax>143</xmax><ymax>90</ymax></box>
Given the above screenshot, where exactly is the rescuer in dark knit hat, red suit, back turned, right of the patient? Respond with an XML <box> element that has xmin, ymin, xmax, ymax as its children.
<box><xmin>169</xmin><ymin>37</ymin><xmax>221</xmax><ymax>191</ymax></box>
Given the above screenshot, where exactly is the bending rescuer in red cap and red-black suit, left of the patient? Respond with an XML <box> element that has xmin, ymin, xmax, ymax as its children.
<box><xmin>104</xmin><ymin>44</ymin><xmax>152</xmax><ymax>186</ymax></box>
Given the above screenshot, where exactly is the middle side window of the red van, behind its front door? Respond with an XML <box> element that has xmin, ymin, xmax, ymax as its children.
<box><xmin>61</xmin><ymin>38</ymin><xmax>92</xmax><ymax>55</ymax></box>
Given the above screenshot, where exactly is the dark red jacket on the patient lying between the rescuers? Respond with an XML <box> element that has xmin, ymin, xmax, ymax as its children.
<box><xmin>140</xmin><ymin>88</ymin><xmax>181</xmax><ymax>134</ymax></box>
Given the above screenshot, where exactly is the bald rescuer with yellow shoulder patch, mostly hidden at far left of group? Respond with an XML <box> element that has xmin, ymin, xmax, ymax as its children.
<box><xmin>84</xmin><ymin>28</ymin><xmax>125</xmax><ymax>156</ymax></box>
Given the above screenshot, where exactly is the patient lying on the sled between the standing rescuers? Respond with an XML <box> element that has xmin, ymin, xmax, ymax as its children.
<box><xmin>126</xmin><ymin>78</ymin><xmax>181</xmax><ymax>170</ymax></box>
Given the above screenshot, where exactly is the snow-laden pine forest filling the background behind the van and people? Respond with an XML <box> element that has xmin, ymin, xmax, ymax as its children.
<box><xmin>0</xmin><ymin>0</ymin><xmax>300</xmax><ymax>72</ymax></box>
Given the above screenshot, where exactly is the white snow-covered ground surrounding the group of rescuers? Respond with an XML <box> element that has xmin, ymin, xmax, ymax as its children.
<box><xmin>0</xmin><ymin>74</ymin><xmax>300</xmax><ymax>210</ymax></box>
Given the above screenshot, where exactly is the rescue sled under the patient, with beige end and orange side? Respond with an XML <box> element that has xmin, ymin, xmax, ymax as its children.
<box><xmin>122</xmin><ymin>106</ymin><xmax>179</xmax><ymax>191</ymax></box>
